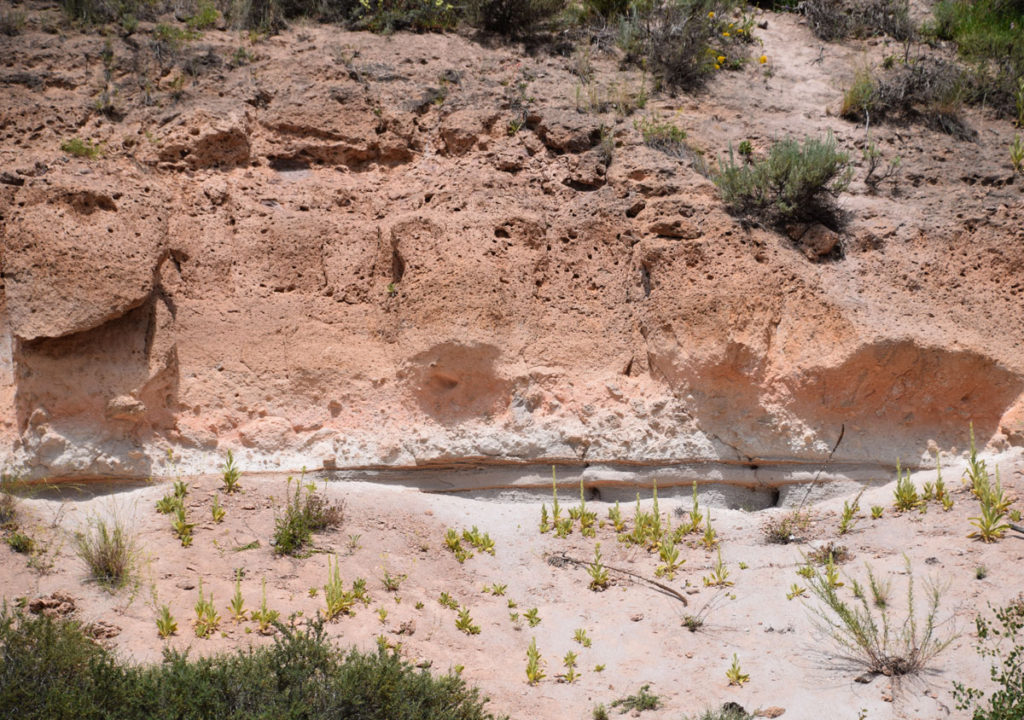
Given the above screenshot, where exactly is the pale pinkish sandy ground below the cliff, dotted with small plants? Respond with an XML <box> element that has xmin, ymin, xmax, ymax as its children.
<box><xmin>0</xmin><ymin>456</ymin><xmax>1024</xmax><ymax>720</ymax></box>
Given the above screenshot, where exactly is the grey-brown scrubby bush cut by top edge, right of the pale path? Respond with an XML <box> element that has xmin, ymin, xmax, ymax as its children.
<box><xmin>803</xmin><ymin>0</ymin><xmax>915</xmax><ymax>41</ymax></box>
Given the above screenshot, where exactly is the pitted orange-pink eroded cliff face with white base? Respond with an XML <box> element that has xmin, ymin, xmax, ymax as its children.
<box><xmin>0</xmin><ymin>18</ymin><xmax>1024</xmax><ymax>477</ymax></box>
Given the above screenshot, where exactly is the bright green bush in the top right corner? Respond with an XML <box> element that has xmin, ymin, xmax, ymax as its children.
<box><xmin>931</xmin><ymin>0</ymin><xmax>1024</xmax><ymax>122</ymax></box>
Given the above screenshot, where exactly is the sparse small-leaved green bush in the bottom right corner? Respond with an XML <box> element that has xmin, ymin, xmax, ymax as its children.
<box><xmin>953</xmin><ymin>595</ymin><xmax>1024</xmax><ymax>720</ymax></box>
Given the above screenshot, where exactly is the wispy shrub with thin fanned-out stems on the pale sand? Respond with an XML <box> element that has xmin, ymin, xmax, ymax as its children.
<box><xmin>806</xmin><ymin>560</ymin><xmax>954</xmax><ymax>676</ymax></box>
